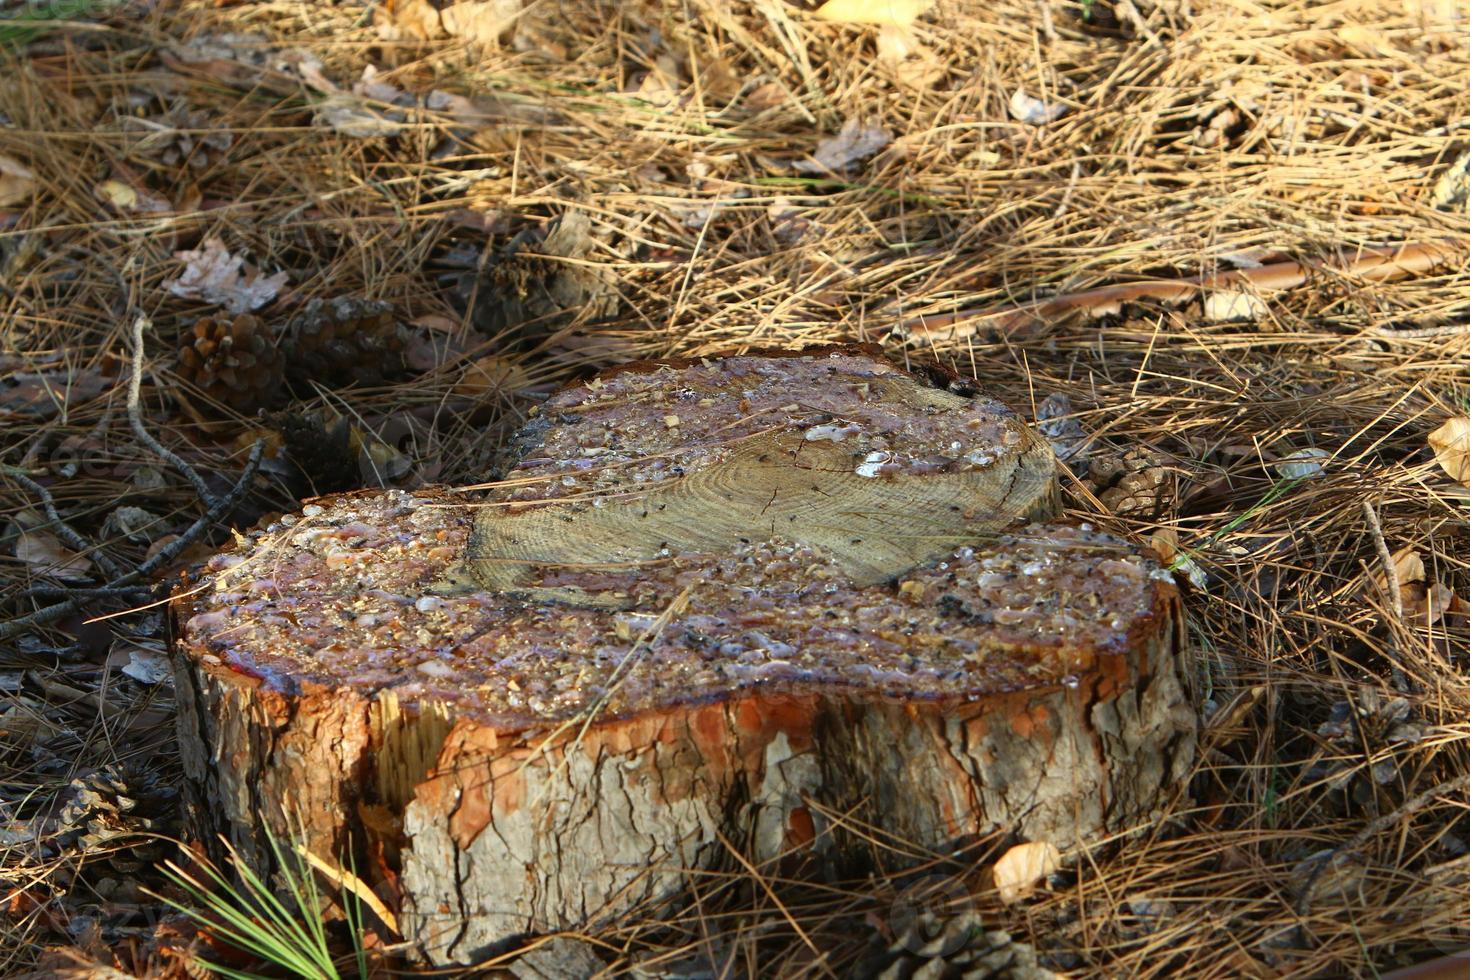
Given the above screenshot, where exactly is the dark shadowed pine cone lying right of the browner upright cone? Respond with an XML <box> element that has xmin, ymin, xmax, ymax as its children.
<box><xmin>285</xmin><ymin>297</ymin><xmax>404</xmax><ymax>391</ymax></box>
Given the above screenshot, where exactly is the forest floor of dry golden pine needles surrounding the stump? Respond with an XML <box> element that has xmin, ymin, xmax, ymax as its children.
<box><xmin>0</xmin><ymin>0</ymin><xmax>1470</xmax><ymax>977</ymax></box>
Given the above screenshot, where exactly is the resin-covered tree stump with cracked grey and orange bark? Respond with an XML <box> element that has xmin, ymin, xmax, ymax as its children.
<box><xmin>173</xmin><ymin>348</ymin><xmax>1197</xmax><ymax>964</ymax></box>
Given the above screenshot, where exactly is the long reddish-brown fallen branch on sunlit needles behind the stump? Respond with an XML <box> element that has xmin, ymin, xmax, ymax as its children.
<box><xmin>894</xmin><ymin>239</ymin><xmax>1466</xmax><ymax>344</ymax></box>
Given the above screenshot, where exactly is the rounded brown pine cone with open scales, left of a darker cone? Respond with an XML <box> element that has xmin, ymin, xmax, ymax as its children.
<box><xmin>178</xmin><ymin>313</ymin><xmax>285</xmax><ymax>414</ymax></box>
